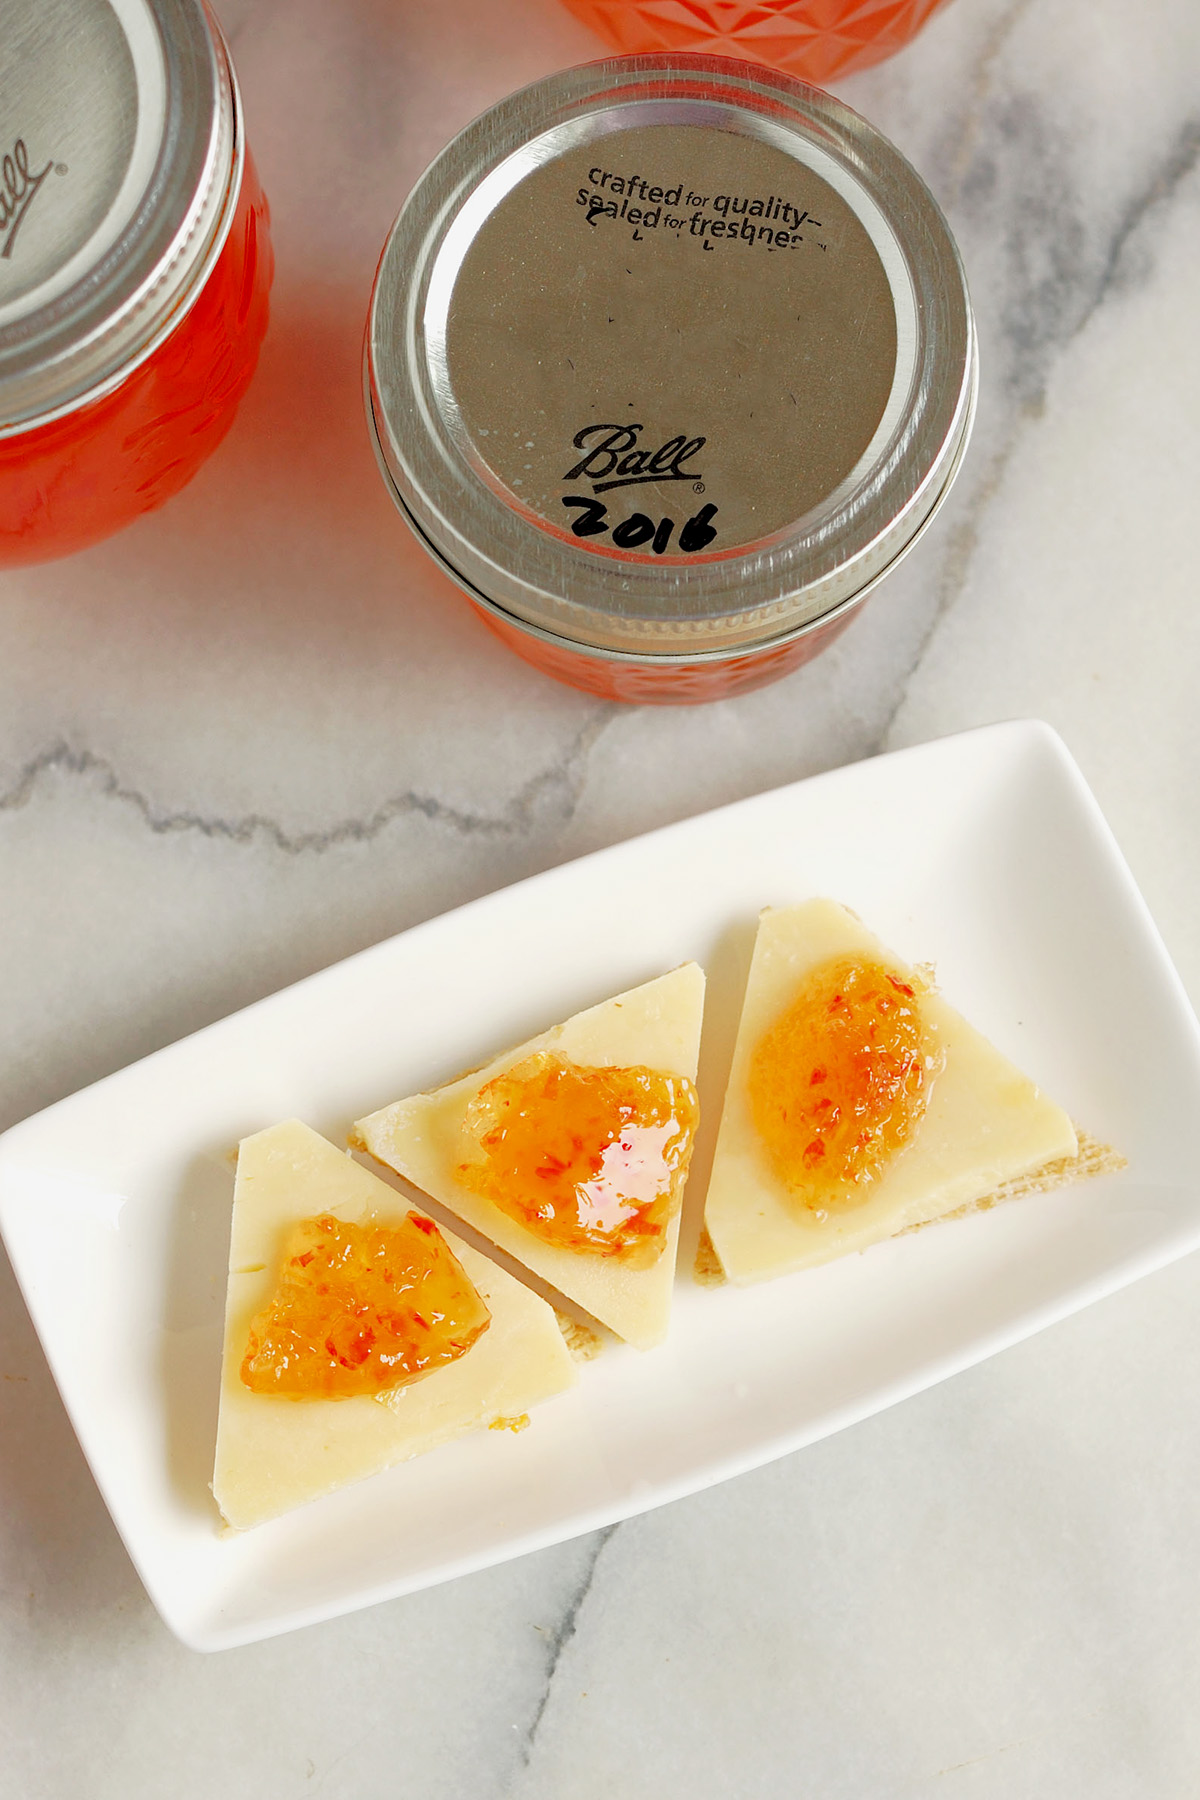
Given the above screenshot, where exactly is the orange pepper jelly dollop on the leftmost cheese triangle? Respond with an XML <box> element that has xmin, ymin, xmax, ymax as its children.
<box><xmin>241</xmin><ymin>1213</ymin><xmax>491</xmax><ymax>1400</ymax></box>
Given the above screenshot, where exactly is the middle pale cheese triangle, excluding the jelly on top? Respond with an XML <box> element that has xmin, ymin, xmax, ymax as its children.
<box><xmin>351</xmin><ymin>963</ymin><xmax>703</xmax><ymax>1350</ymax></box>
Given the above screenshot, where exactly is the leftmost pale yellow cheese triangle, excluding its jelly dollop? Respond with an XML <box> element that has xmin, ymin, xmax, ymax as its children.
<box><xmin>212</xmin><ymin>1120</ymin><xmax>576</xmax><ymax>1528</ymax></box>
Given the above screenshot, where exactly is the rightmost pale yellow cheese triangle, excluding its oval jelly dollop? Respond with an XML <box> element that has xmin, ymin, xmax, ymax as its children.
<box><xmin>705</xmin><ymin>900</ymin><xmax>1078</xmax><ymax>1282</ymax></box>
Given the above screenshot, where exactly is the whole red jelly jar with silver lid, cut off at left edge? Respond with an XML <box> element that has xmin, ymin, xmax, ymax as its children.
<box><xmin>0</xmin><ymin>0</ymin><xmax>273</xmax><ymax>567</ymax></box>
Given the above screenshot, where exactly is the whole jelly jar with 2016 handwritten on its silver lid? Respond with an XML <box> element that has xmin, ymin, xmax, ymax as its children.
<box><xmin>365</xmin><ymin>56</ymin><xmax>977</xmax><ymax>702</ymax></box>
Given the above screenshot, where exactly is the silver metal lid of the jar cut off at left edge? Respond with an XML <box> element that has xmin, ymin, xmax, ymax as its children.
<box><xmin>0</xmin><ymin>0</ymin><xmax>243</xmax><ymax>436</ymax></box>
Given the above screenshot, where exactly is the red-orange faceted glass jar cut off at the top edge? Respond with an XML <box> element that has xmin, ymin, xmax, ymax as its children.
<box><xmin>563</xmin><ymin>0</ymin><xmax>946</xmax><ymax>83</ymax></box>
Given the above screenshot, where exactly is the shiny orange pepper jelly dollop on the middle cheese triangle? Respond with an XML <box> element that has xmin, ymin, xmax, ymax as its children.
<box><xmin>459</xmin><ymin>1049</ymin><xmax>700</xmax><ymax>1269</ymax></box>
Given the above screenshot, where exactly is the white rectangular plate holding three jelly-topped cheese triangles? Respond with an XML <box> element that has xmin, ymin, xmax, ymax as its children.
<box><xmin>0</xmin><ymin>724</ymin><xmax>1200</xmax><ymax>1649</ymax></box>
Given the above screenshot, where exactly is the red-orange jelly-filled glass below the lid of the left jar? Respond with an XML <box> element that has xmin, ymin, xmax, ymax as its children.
<box><xmin>0</xmin><ymin>155</ymin><xmax>273</xmax><ymax>569</ymax></box>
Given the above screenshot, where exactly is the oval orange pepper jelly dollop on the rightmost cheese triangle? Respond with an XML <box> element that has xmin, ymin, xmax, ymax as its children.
<box><xmin>748</xmin><ymin>956</ymin><xmax>943</xmax><ymax>1215</ymax></box>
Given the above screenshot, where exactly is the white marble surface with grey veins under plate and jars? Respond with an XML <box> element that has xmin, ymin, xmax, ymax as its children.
<box><xmin>0</xmin><ymin>0</ymin><xmax>1200</xmax><ymax>1800</ymax></box>
